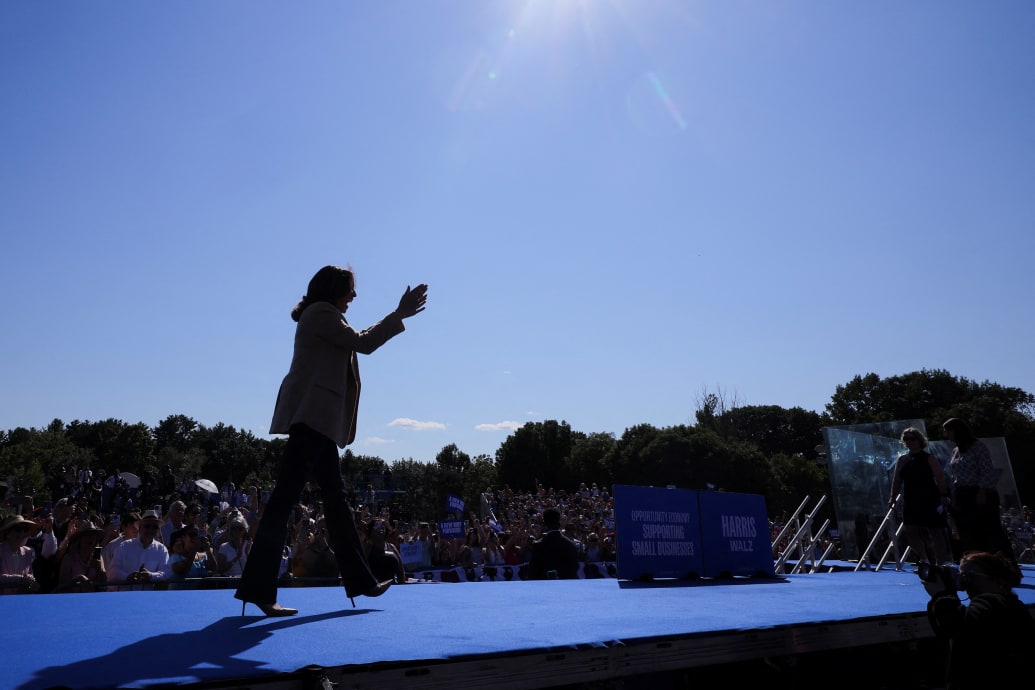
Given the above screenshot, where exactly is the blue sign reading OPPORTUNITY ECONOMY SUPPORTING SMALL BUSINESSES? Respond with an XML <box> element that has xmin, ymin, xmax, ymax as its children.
<box><xmin>614</xmin><ymin>484</ymin><xmax>702</xmax><ymax>579</ymax></box>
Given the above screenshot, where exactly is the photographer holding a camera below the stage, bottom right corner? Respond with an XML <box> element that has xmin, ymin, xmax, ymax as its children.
<box><xmin>919</xmin><ymin>551</ymin><xmax>1035</xmax><ymax>690</ymax></box>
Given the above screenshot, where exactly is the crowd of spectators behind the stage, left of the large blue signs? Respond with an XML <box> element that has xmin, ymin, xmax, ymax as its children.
<box><xmin>0</xmin><ymin>481</ymin><xmax>616</xmax><ymax>594</ymax></box>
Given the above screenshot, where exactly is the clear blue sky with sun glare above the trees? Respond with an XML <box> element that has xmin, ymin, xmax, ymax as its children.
<box><xmin>0</xmin><ymin>0</ymin><xmax>1035</xmax><ymax>462</ymax></box>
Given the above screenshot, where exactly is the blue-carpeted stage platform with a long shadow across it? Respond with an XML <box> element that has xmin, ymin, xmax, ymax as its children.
<box><xmin>6</xmin><ymin>566</ymin><xmax>1035</xmax><ymax>690</ymax></box>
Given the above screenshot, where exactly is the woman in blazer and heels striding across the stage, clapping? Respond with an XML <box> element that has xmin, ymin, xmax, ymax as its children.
<box><xmin>235</xmin><ymin>266</ymin><xmax>427</xmax><ymax>616</ymax></box>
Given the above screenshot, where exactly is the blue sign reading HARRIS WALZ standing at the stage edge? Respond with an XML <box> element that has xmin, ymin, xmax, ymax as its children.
<box><xmin>698</xmin><ymin>491</ymin><xmax>775</xmax><ymax>577</ymax></box>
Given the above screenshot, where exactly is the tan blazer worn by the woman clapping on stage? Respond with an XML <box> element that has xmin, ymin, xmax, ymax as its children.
<box><xmin>269</xmin><ymin>302</ymin><xmax>406</xmax><ymax>448</ymax></box>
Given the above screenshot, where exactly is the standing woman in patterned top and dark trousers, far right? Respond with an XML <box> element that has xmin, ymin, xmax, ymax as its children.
<box><xmin>942</xmin><ymin>417</ymin><xmax>1013</xmax><ymax>557</ymax></box>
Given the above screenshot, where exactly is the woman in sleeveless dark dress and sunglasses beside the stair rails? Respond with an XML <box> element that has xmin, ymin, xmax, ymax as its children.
<box><xmin>888</xmin><ymin>426</ymin><xmax>952</xmax><ymax>564</ymax></box>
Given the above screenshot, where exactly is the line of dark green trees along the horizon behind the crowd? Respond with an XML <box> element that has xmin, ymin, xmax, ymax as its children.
<box><xmin>0</xmin><ymin>369</ymin><xmax>1035</xmax><ymax>519</ymax></box>
